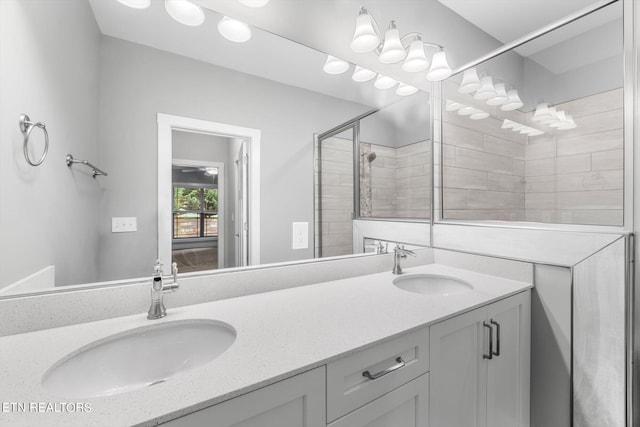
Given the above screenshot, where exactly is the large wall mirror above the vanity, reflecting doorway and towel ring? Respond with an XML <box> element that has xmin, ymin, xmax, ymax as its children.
<box><xmin>0</xmin><ymin>0</ymin><xmax>431</xmax><ymax>293</ymax></box>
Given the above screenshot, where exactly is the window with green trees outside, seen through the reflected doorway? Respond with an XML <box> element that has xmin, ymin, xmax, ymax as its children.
<box><xmin>173</xmin><ymin>186</ymin><xmax>218</xmax><ymax>239</ymax></box>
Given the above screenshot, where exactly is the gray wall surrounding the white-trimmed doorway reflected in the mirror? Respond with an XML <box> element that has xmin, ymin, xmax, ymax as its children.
<box><xmin>100</xmin><ymin>37</ymin><xmax>369</xmax><ymax>278</ymax></box>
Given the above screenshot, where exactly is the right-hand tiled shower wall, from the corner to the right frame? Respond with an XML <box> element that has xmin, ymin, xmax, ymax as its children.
<box><xmin>525</xmin><ymin>89</ymin><xmax>624</xmax><ymax>225</ymax></box>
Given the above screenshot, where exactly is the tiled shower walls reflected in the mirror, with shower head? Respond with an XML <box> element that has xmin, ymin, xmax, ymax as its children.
<box><xmin>315</xmin><ymin>137</ymin><xmax>431</xmax><ymax>257</ymax></box>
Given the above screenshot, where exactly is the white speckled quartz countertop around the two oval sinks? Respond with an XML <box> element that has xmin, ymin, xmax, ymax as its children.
<box><xmin>0</xmin><ymin>264</ymin><xmax>532</xmax><ymax>426</ymax></box>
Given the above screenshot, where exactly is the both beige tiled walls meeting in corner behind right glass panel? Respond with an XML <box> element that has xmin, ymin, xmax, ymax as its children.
<box><xmin>436</xmin><ymin>87</ymin><xmax>623</xmax><ymax>229</ymax></box>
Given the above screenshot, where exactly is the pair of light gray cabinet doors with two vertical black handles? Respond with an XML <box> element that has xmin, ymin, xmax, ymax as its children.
<box><xmin>429</xmin><ymin>291</ymin><xmax>531</xmax><ymax>427</ymax></box>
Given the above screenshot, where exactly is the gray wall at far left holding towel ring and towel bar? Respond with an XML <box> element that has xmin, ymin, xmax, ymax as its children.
<box><xmin>0</xmin><ymin>0</ymin><xmax>101</xmax><ymax>287</ymax></box>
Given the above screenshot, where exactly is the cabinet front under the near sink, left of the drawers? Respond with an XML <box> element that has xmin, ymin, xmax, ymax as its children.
<box><xmin>163</xmin><ymin>366</ymin><xmax>326</xmax><ymax>427</ymax></box>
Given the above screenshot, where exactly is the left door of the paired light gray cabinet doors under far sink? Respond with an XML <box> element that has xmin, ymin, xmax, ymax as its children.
<box><xmin>429</xmin><ymin>308</ymin><xmax>484</xmax><ymax>427</ymax></box>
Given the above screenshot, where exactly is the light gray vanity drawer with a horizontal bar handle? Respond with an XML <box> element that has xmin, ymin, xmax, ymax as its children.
<box><xmin>327</xmin><ymin>328</ymin><xmax>429</xmax><ymax>422</ymax></box>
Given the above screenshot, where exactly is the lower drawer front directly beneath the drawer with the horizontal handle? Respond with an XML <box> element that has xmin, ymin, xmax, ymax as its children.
<box><xmin>329</xmin><ymin>374</ymin><xmax>429</xmax><ymax>427</ymax></box>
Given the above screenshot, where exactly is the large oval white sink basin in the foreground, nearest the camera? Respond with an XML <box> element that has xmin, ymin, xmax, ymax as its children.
<box><xmin>42</xmin><ymin>320</ymin><xmax>236</xmax><ymax>398</ymax></box>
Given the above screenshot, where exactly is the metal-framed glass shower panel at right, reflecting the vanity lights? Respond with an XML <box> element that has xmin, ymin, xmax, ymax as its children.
<box><xmin>442</xmin><ymin>2</ymin><xmax>623</xmax><ymax>226</ymax></box>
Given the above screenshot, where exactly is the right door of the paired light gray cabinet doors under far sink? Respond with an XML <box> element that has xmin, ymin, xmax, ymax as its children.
<box><xmin>487</xmin><ymin>292</ymin><xmax>531</xmax><ymax>427</ymax></box>
